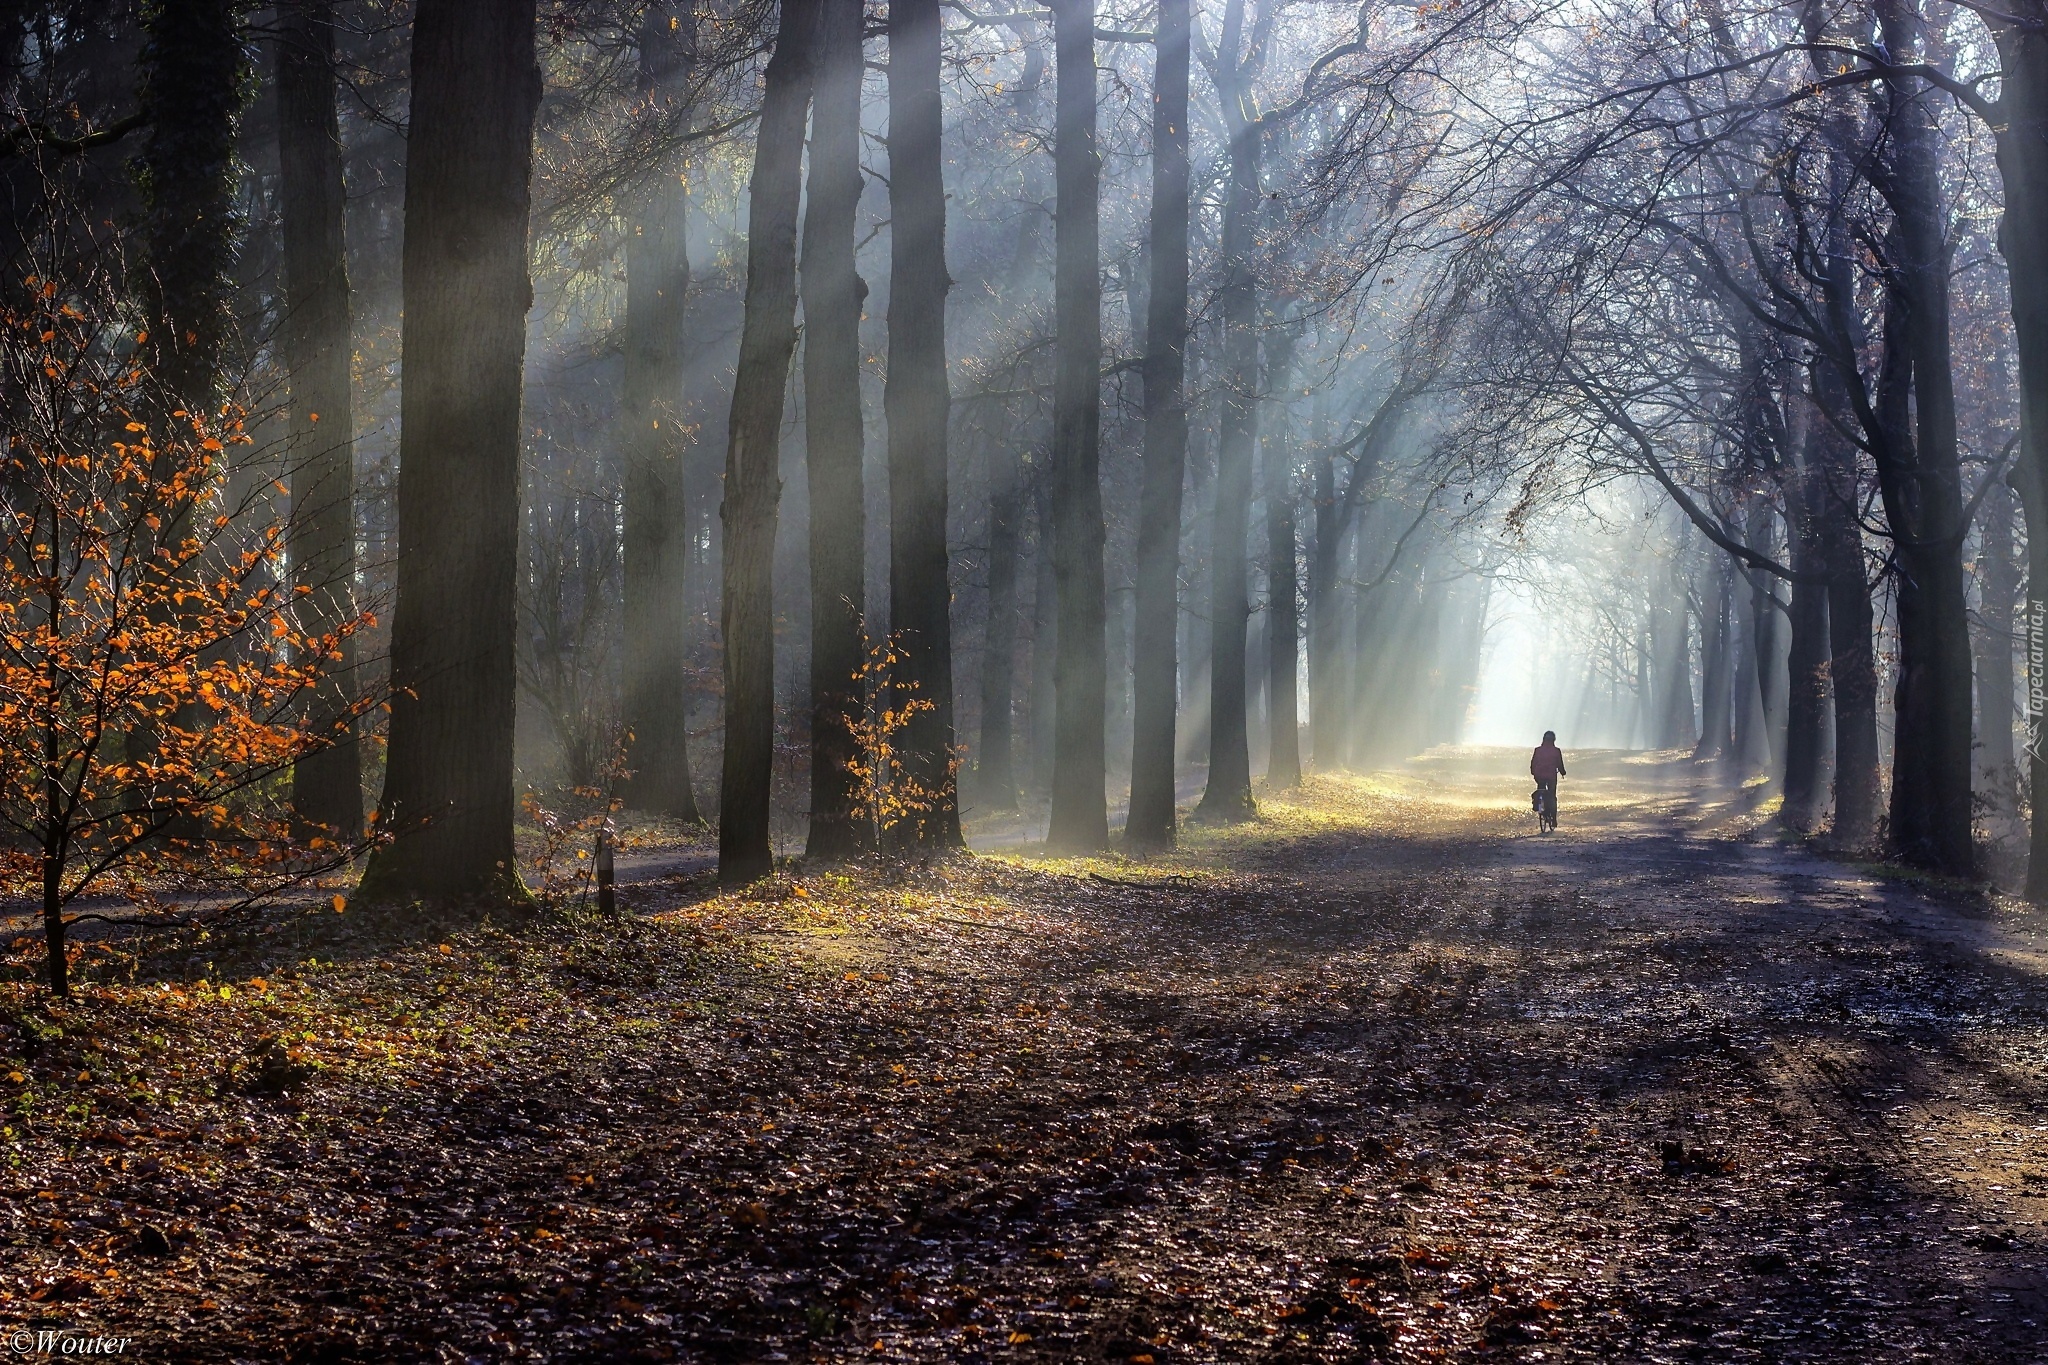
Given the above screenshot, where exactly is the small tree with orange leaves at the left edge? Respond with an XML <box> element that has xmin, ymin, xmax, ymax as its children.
<box><xmin>0</xmin><ymin>280</ymin><xmax>373</xmax><ymax>995</ymax></box>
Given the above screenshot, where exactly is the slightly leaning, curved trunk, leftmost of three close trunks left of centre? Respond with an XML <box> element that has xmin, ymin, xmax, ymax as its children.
<box><xmin>719</xmin><ymin>0</ymin><xmax>821</xmax><ymax>886</ymax></box>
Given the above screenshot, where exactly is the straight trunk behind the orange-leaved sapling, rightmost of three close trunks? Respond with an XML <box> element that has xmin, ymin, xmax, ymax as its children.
<box><xmin>883</xmin><ymin>0</ymin><xmax>963</xmax><ymax>851</ymax></box>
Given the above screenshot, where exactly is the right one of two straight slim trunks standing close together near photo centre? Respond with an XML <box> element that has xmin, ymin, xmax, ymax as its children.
<box><xmin>1124</xmin><ymin>0</ymin><xmax>1190</xmax><ymax>847</ymax></box>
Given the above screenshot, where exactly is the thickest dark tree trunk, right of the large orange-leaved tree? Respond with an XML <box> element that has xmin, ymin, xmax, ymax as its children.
<box><xmin>358</xmin><ymin>0</ymin><xmax>541</xmax><ymax>900</ymax></box>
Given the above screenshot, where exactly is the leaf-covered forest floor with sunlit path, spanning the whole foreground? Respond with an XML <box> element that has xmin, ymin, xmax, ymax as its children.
<box><xmin>0</xmin><ymin>749</ymin><xmax>2048</xmax><ymax>1365</ymax></box>
